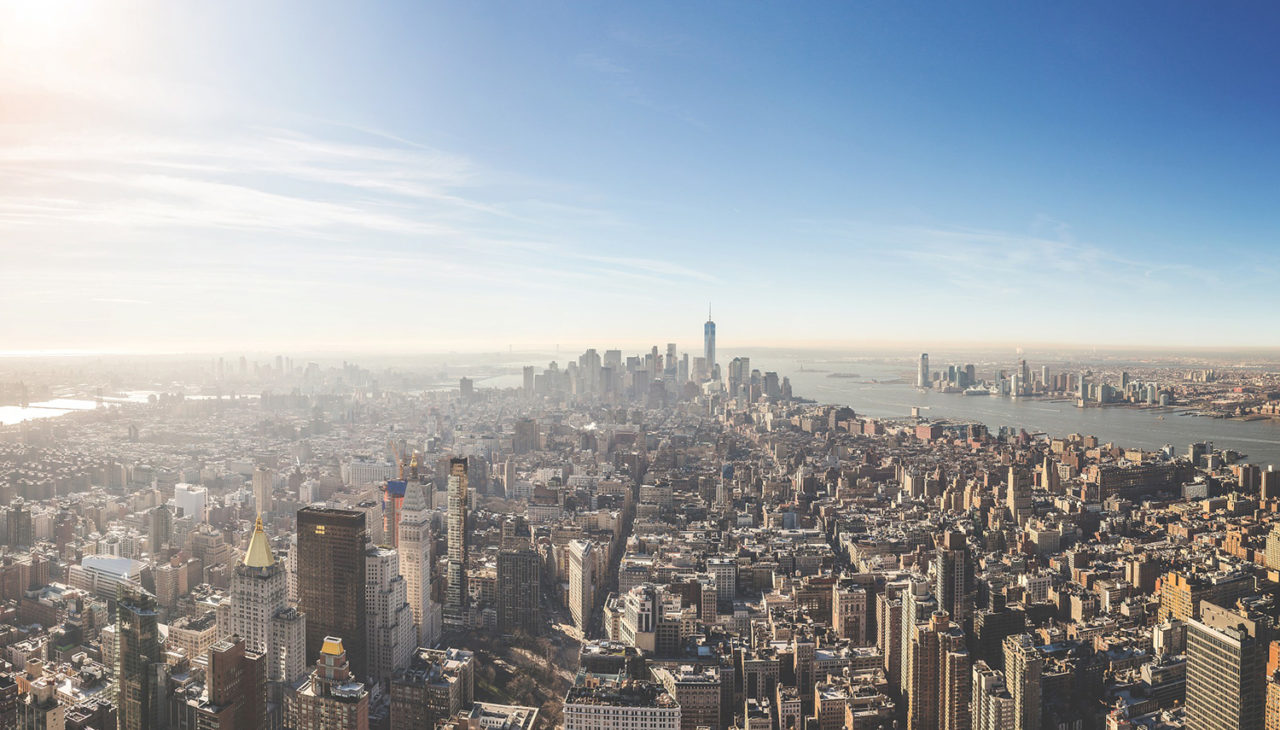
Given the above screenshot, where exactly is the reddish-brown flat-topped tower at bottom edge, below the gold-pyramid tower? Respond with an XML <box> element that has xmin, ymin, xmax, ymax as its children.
<box><xmin>202</xmin><ymin>635</ymin><xmax>268</xmax><ymax>730</ymax></box>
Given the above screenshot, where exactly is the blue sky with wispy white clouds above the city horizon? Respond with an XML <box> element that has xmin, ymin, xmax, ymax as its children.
<box><xmin>0</xmin><ymin>1</ymin><xmax>1280</xmax><ymax>351</ymax></box>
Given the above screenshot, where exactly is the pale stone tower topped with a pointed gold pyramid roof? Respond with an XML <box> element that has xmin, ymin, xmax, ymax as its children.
<box><xmin>229</xmin><ymin>517</ymin><xmax>307</xmax><ymax>683</ymax></box>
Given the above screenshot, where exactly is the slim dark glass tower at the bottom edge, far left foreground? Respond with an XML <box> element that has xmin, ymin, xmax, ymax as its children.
<box><xmin>115</xmin><ymin>584</ymin><xmax>165</xmax><ymax>730</ymax></box>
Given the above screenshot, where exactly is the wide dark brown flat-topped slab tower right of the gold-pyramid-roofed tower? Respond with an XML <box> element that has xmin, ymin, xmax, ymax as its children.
<box><xmin>298</xmin><ymin>507</ymin><xmax>369</xmax><ymax>679</ymax></box>
